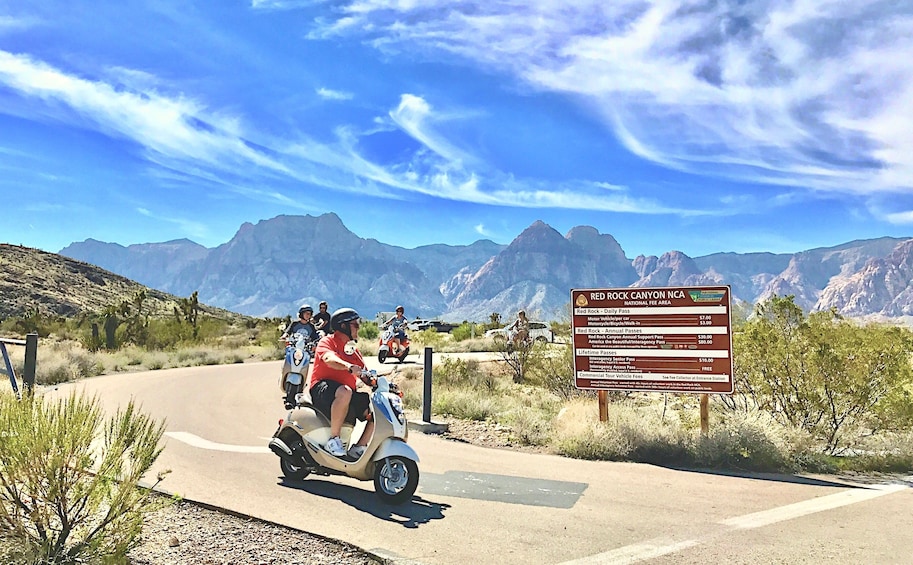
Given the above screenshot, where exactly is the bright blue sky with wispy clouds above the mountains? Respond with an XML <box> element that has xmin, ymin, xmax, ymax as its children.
<box><xmin>0</xmin><ymin>0</ymin><xmax>913</xmax><ymax>257</ymax></box>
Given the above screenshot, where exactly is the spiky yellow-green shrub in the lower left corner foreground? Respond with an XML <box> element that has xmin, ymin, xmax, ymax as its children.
<box><xmin>0</xmin><ymin>393</ymin><xmax>164</xmax><ymax>564</ymax></box>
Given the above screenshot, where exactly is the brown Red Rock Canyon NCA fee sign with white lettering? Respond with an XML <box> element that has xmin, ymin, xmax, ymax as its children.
<box><xmin>571</xmin><ymin>286</ymin><xmax>733</xmax><ymax>394</ymax></box>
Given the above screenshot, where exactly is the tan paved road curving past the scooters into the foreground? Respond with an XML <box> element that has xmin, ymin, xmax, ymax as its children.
<box><xmin>50</xmin><ymin>356</ymin><xmax>913</xmax><ymax>565</ymax></box>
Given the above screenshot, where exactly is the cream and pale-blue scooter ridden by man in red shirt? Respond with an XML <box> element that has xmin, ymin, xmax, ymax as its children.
<box><xmin>269</xmin><ymin>370</ymin><xmax>419</xmax><ymax>504</ymax></box>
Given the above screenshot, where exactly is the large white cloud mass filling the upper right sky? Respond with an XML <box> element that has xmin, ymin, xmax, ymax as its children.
<box><xmin>311</xmin><ymin>0</ymin><xmax>913</xmax><ymax>194</ymax></box>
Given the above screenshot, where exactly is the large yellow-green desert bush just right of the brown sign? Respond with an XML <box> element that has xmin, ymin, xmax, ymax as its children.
<box><xmin>733</xmin><ymin>296</ymin><xmax>913</xmax><ymax>454</ymax></box>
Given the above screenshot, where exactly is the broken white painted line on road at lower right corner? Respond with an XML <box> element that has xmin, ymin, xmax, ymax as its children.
<box><xmin>561</xmin><ymin>485</ymin><xmax>910</xmax><ymax>565</ymax></box>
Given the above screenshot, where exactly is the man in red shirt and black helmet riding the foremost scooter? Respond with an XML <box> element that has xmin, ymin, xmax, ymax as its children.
<box><xmin>308</xmin><ymin>308</ymin><xmax>374</xmax><ymax>459</ymax></box>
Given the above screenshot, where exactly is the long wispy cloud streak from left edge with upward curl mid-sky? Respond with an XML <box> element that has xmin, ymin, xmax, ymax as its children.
<box><xmin>0</xmin><ymin>43</ymin><xmax>703</xmax><ymax>216</ymax></box>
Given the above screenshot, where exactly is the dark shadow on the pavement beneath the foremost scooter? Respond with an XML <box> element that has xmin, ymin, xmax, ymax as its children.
<box><xmin>278</xmin><ymin>478</ymin><xmax>450</xmax><ymax>528</ymax></box>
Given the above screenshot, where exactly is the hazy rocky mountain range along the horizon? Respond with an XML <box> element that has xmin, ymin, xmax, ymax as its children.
<box><xmin>60</xmin><ymin>213</ymin><xmax>913</xmax><ymax>321</ymax></box>
